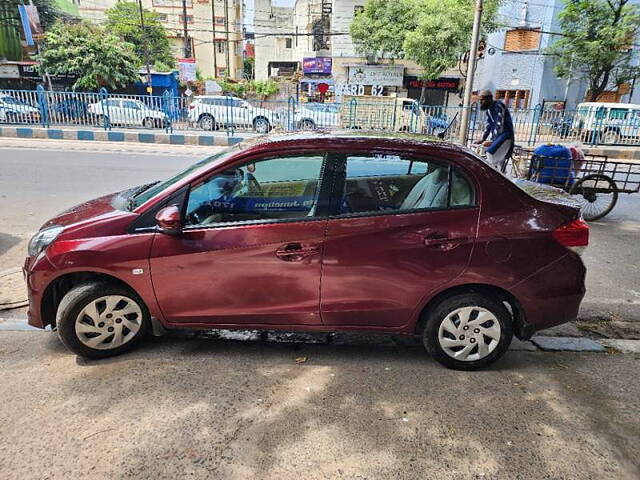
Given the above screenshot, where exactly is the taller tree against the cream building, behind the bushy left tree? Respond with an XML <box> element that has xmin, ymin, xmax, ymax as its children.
<box><xmin>105</xmin><ymin>2</ymin><xmax>175</xmax><ymax>68</ymax></box>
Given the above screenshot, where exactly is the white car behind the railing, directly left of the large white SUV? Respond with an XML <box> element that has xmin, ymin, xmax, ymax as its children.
<box><xmin>87</xmin><ymin>98</ymin><xmax>168</xmax><ymax>128</ymax></box>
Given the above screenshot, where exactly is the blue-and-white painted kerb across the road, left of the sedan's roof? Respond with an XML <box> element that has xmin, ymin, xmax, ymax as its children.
<box><xmin>0</xmin><ymin>126</ymin><xmax>244</xmax><ymax>147</ymax></box>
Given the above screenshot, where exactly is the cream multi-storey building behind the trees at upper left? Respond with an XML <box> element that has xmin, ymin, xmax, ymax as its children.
<box><xmin>78</xmin><ymin>0</ymin><xmax>243</xmax><ymax>80</ymax></box>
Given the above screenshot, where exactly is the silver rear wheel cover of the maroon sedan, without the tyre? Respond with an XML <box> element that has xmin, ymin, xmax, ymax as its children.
<box><xmin>438</xmin><ymin>306</ymin><xmax>502</xmax><ymax>362</ymax></box>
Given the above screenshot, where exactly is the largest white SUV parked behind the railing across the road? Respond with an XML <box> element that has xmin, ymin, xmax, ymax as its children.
<box><xmin>189</xmin><ymin>95</ymin><xmax>280</xmax><ymax>133</ymax></box>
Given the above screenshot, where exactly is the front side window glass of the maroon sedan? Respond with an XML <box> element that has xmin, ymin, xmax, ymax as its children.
<box><xmin>186</xmin><ymin>155</ymin><xmax>324</xmax><ymax>227</ymax></box>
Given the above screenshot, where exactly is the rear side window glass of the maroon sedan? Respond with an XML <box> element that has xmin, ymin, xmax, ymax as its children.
<box><xmin>341</xmin><ymin>154</ymin><xmax>474</xmax><ymax>214</ymax></box>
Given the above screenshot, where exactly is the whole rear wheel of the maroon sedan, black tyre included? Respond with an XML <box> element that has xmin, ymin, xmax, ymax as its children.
<box><xmin>423</xmin><ymin>293</ymin><xmax>513</xmax><ymax>371</ymax></box>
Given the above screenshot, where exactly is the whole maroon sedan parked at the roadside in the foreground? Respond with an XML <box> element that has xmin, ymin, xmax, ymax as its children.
<box><xmin>24</xmin><ymin>133</ymin><xmax>589</xmax><ymax>370</ymax></box>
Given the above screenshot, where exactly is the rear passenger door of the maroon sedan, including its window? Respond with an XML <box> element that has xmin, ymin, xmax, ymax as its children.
<box><xmin>321</xmin><ymin>152</ymin><xmax>479</xmax><ymax>328</ymax></box>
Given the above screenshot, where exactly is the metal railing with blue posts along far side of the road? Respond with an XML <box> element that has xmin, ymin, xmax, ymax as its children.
<box><xmin>0</xmin><ymin>87</ymin><xmax>640</xmax><ymax>146</ymax></box>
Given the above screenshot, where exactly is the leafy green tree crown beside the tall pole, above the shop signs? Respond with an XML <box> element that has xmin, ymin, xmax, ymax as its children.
<box><xmin>351</xmin><ymin>0</ymin><xmax>500</xmax><ymax>80</ymax></box>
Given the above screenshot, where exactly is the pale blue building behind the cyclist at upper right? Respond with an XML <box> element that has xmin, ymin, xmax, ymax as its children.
<box><xmin>474</xmin><ymin>0</ymin><xmax>640</xmax><ymax>109</ymax></box>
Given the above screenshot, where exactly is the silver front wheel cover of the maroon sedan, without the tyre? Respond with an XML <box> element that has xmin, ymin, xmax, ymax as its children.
<box><xmin>75</xmin><ymin>295</ymin><xmax>143</xmax><ymax>350</ymax></box>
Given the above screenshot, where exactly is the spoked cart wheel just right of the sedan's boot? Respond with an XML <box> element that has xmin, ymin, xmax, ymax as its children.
<box><xmin>569</xmin><ymin>173</ymin><xmax>618</xmax><ymax>222</ymax></box>
